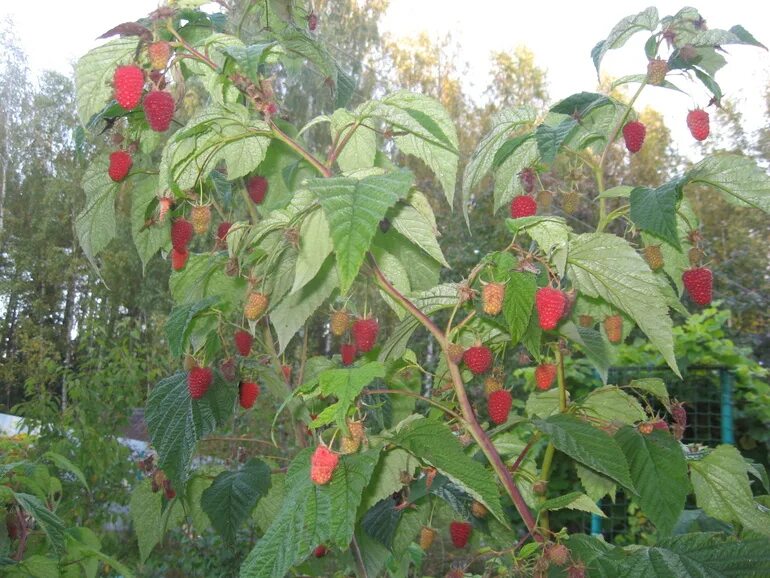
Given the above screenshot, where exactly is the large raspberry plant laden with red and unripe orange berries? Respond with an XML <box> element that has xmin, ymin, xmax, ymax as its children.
<box><xmin>66</xmin><ymin>2</ymin><xmax>770</xmax><ymax>577</ymax></box>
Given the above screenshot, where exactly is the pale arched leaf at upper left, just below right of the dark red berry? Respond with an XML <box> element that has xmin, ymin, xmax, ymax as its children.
<box><xmin>159</xmin><ymin>103</ymin><xmax>272</xmax><ymax>189</ymax></box>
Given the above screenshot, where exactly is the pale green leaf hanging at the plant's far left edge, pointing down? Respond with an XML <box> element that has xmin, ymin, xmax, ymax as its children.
<box><xmin>75</xmin><ymin>155</ymin><xmax>118</xmax><ymax>269</ymax></box>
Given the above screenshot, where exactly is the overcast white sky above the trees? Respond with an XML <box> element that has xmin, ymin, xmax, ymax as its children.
<box><xmin>0</xmin><ymin>0</ymin><xmax>770</xmax><ymax>151</ymax></box>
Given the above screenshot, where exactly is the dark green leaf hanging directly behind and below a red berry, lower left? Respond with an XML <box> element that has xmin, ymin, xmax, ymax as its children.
<box><xmin>145</xmin><ymin>372</ymin><xmax>236</xmax><ymax>486</ymax></box>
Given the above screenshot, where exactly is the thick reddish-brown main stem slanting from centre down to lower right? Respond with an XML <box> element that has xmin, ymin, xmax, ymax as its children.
<box><xmin>369</xmin><ymin>255</ymin><xmax>543</xmax><ymax>542</ymax></box>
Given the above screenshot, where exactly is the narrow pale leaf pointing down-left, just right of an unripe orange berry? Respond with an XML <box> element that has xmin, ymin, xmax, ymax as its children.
<box><xmin>270</xmin><ymin>257</ymin><xmax>339</xmax><ymax>353</ymax></box>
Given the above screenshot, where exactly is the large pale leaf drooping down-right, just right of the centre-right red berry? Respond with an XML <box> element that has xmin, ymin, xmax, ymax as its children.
<box><xmin>567</xmin><ymin>233</ymin><xmax>681</xmax><ymax>377</ymax></box>
